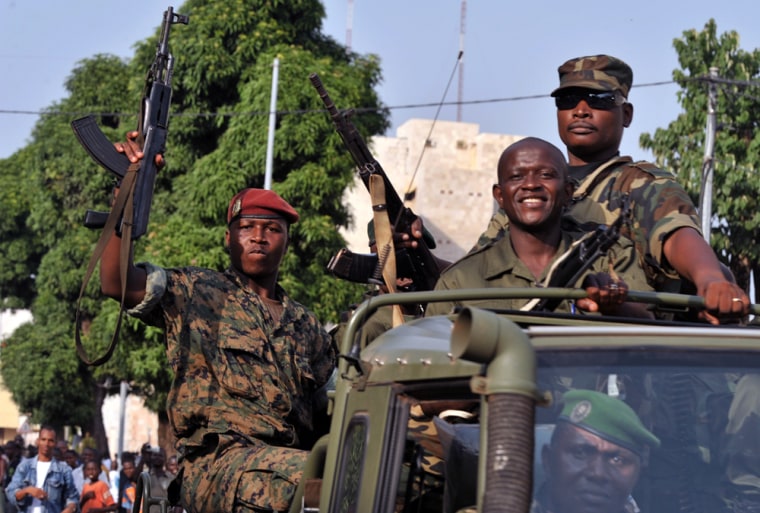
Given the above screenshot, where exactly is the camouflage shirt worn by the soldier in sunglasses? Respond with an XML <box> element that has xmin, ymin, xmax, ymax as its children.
<box><xmin>473</xmin><ymin>157</ymin><xmax>702</xmax><ymax>291</ymax></box>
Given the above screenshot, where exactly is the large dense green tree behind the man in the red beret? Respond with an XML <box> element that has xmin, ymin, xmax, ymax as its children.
<box><xmin>0</xmin><ymin>0</ymin><xmax>388</xmax><ymax>449</ymax></box>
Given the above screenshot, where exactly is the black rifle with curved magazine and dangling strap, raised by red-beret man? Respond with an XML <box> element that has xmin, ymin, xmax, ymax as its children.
<box><xmin>71</xmin><ymin>6</ymin><xmax>190</xmax><ymax>365</ymax></box>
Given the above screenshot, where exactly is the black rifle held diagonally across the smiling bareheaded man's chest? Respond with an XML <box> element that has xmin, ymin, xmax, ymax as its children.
<box><xmin>530</xmin><ymin>195</ymin><xmax>631</xmax><ymax>312</ymax></box>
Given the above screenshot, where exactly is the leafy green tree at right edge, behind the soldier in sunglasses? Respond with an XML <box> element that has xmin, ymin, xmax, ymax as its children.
<box><xmin>639</xmin><ymin>20</ymin><xmax>760</xmax><ymax>301</ymax></box>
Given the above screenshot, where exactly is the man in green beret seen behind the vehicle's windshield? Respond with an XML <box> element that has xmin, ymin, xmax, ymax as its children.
<box><xmin>531</xmin><ymin>390</ymin><xmax>660</xmax><ymax>513</ymax></box>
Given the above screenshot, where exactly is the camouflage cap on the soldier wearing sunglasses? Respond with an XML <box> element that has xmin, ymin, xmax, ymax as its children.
<box><xmin>552</xmin><ymin>55</ymin><xmax>633</xmax><ymax>98</ymax></box>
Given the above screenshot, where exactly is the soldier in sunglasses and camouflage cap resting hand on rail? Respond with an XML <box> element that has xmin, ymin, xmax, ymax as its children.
<box><xmin>476</xmin><ymin>55</ymin><xmax>750</xmax><ymax>324</ymax></box>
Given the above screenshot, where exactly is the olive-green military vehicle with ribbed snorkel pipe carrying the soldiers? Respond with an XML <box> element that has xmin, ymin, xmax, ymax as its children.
<box><xmin>291</xmin><ymin>289</ymin><xmax>760</xmax><ymax>513</ymax></box>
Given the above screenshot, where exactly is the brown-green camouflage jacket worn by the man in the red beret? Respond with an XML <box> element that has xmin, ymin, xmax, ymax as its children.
<box><xmin>130</xmin><ymin>264</ymin><xmax>336</xmax><ymax>450</ymax></box>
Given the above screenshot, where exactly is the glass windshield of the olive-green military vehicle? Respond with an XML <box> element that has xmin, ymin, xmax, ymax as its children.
<box><xmin>534</xmin><ymin>348</ymin><xmax>760</xmax><ymax>513</ymax></box>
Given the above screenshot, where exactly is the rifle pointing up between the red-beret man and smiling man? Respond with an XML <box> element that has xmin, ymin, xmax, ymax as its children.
<box><xmin>309</xmin><ymin>73</ymin><xmax>440</xmax><ymax>290</ymax></box>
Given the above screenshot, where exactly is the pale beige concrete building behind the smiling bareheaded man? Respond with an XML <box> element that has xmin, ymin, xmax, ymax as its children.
<box><xmin>343</xmin><ymin>119</ymin><xmax>523</xmax><ymax>261</ymax></box>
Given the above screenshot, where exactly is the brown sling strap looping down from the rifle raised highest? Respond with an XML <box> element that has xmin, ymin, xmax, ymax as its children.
<box><xmin>75</xmin><ymin>163</ymin><xmax>140</xmax><ymax>365</ymax></box>
